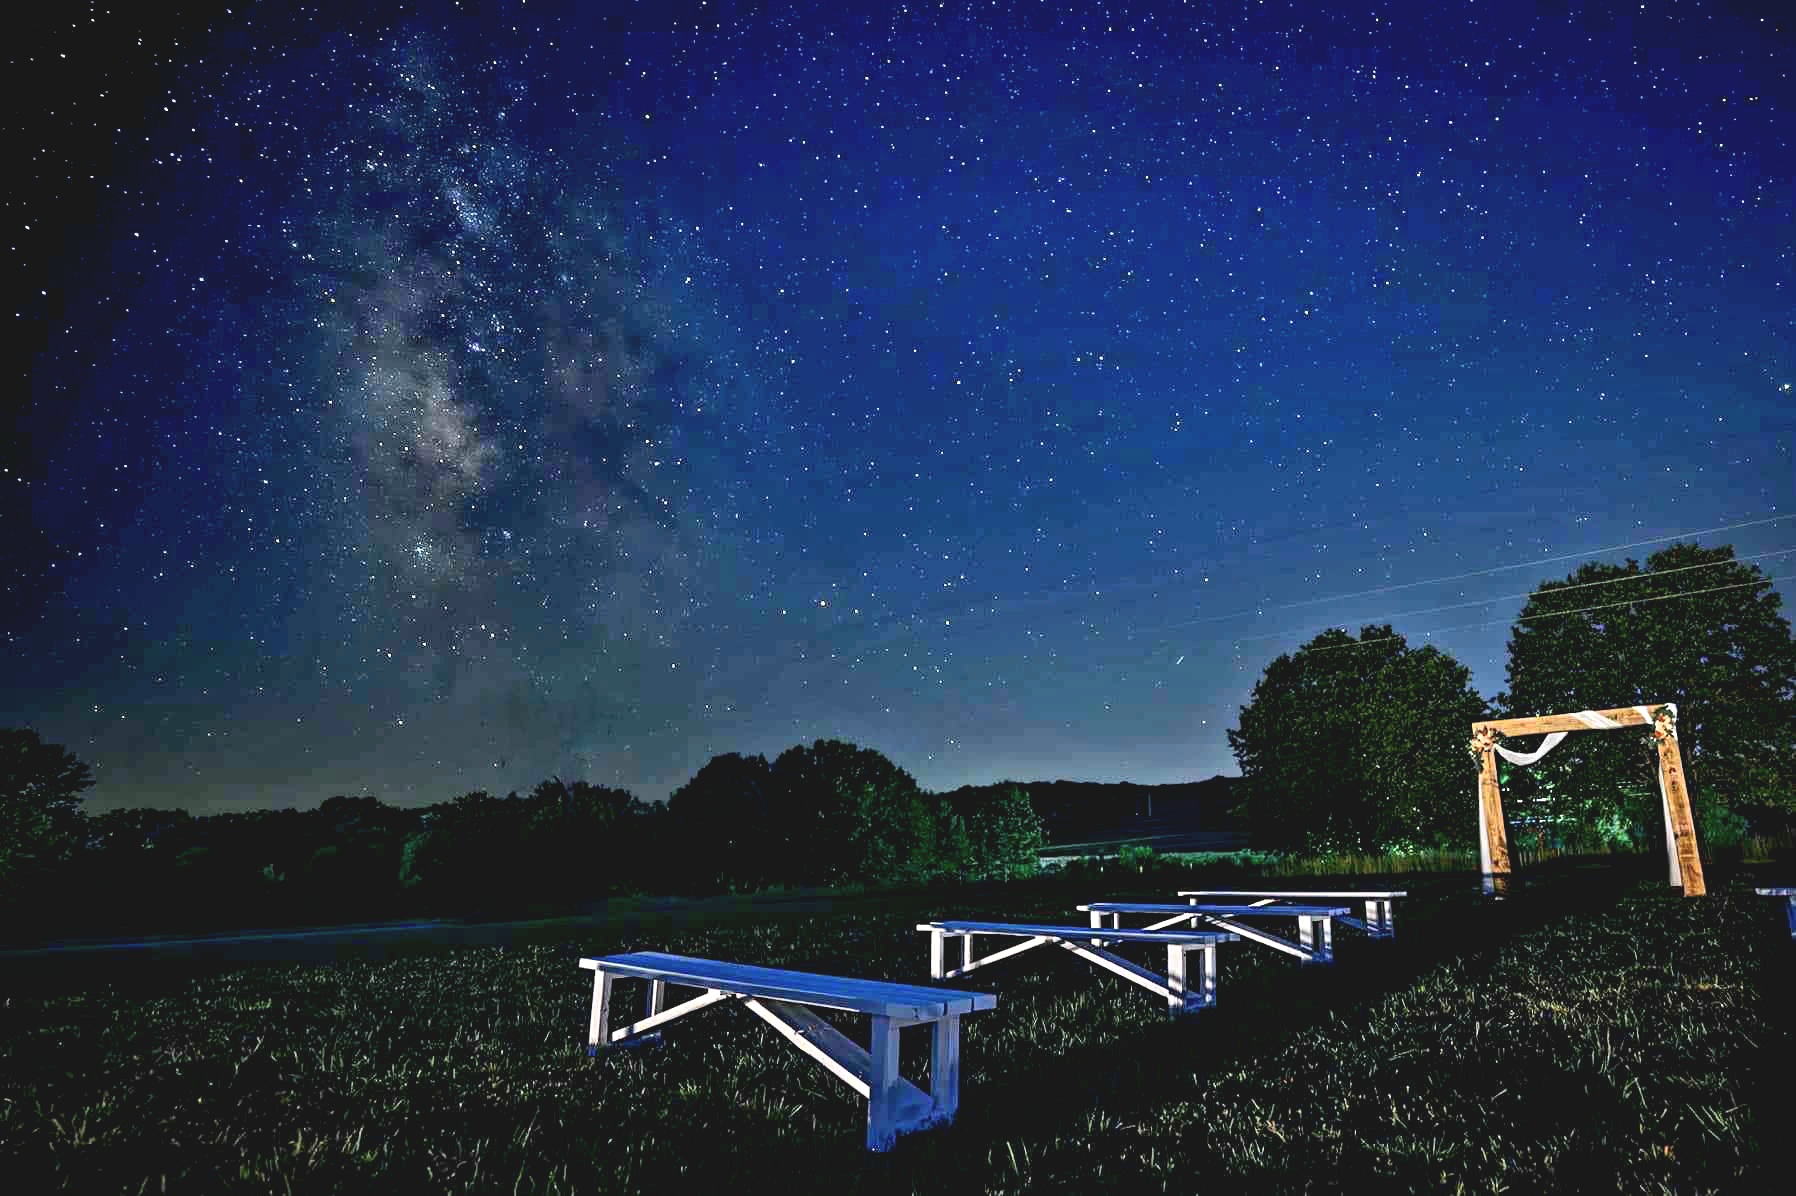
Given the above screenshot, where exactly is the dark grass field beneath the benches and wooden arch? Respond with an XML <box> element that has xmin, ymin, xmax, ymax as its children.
<box><xmin>0</xmin><ymin>867</ymin><xmax>1796</xmax><ymax>1192</ymax></box>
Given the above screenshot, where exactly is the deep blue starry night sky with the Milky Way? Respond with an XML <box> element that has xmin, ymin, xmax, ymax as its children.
<box><xmin>0</xmin><ymin>0</ymin><xmax>1796</xmax><ymax>812</ymax></box>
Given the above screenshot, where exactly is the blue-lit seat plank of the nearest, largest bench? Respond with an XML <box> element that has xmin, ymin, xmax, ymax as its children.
<box><xmin>580</xmin><ymin>952</ymin><xmax>997</xmax><ymax>1022</ymax></box>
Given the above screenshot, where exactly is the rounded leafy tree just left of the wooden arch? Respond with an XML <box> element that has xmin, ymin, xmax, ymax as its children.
<box><xmin>1228</xmin><ymin>625</ymin><xmax>1489</xmax><ymax>851</ymax></box>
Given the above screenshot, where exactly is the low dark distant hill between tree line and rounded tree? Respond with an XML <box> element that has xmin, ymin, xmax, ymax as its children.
<box><xmin>946</xmin><ymin>776</ymin><xmax>1245</xmax><ymax>846</ymax></box>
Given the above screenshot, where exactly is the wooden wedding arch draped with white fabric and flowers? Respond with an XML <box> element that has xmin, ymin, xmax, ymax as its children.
<box><xmin>1471</xmin><ymin>702</ymin><xmax>1706</xmax><ymax>896</ymax></box>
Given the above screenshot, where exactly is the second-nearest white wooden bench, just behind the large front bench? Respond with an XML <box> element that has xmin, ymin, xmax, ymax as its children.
<box><xmin>918</xmin><ymin>921</ymin><xmax>1236</xmax><ymax>1016</ymax></box>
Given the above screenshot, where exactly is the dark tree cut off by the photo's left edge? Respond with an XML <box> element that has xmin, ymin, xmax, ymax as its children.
<box><xmin>0</xmin><ymin>727</ymin><xmax>93</xmax><ymax>887</ymax></box>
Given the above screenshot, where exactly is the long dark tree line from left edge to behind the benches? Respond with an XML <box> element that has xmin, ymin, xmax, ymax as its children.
<box><xmin>0</xmin><ymin>729</ymin><xmax>1042</xmax><ymax>939</ymax></box>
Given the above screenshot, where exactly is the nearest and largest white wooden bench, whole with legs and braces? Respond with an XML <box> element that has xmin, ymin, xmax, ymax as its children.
<box><xmin>580</xmin><ymin>952</ymin><xmax>999</xmax><ymax>1151</ymax></box>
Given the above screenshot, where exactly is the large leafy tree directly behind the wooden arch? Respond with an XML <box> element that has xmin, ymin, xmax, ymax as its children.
<box><xmin>1498</xmin><ymin>544</ymin><xmax>1796</xmax><ymax>840</ymax></box>
